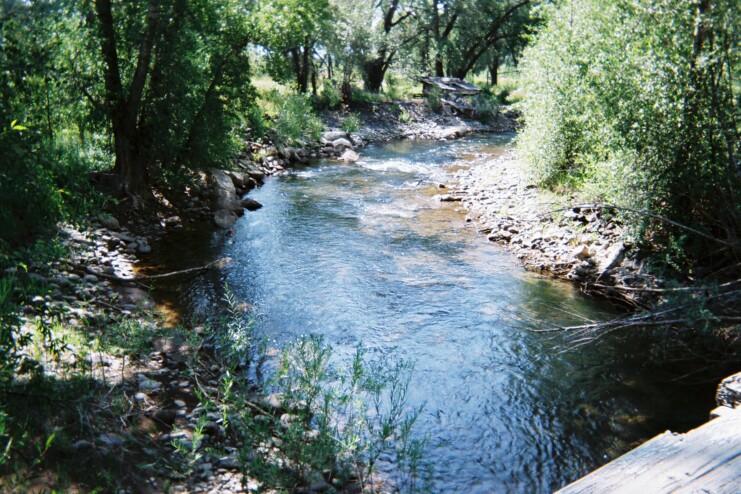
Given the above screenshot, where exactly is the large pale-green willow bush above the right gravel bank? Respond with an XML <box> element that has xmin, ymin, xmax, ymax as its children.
<box><xmin>519</xmin><ymin>0</ymin><xmax>741</xmax><ymax>269</ymax></box>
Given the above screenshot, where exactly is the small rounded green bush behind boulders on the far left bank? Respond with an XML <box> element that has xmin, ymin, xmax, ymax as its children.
<box><xmin>273</xmin><ymin>94</ymin><xmax>322</xmax><ymax>145</ymax></box>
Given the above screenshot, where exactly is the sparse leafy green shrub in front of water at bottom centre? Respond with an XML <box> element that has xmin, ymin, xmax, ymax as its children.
<box><xmin>243</xmin><ymin>336</ymin><xmax>426</xmax><ymax>492</ymax></box>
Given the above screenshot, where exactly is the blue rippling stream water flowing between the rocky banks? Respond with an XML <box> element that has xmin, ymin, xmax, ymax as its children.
<box><xmin>156</xmin><ymin>136</ymin><xmax>712</xmax><ymax>493</ymax></box>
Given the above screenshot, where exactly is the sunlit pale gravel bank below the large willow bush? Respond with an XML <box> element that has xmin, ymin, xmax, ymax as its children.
<box><xmin>450</xmin><ymin>152</ymin><xmax>663</xmax><ymax>307</ymax></box>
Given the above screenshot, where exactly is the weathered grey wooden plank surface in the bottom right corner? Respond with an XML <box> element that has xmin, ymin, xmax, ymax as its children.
<box><xmin>558</xmin><ymin>374</ymin><xmax>741</xmax><ymax>494</ymax></box>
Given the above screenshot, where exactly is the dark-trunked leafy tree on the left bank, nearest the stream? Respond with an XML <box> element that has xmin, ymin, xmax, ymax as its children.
<box><xmin>85</xmin><ymin>0</ymin><xmax>251</xmax><ymax>197</ymax></box>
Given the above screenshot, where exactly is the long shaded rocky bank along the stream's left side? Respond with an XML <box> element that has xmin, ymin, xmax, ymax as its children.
<box><xmin>0</xmin><ymin>104</ymin><xmax>514</xmax><ymax>492</ymax></box>
